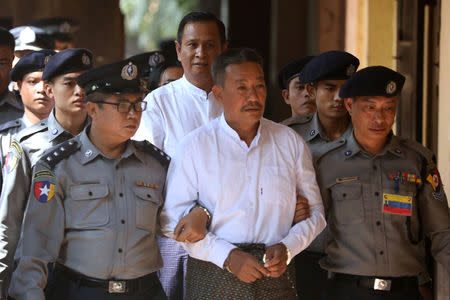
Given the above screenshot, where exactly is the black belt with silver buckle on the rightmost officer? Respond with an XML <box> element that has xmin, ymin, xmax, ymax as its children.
<box><xmin>330</xmin><ymin>273</ymin><xmax>418</xmax><ymax>291</ymax></box>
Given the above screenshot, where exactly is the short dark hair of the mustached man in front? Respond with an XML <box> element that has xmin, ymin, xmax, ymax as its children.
<box><xmin>212</xmin><ymin>48</ymin><xmax>263</xmax><ymax>86</ymax></box>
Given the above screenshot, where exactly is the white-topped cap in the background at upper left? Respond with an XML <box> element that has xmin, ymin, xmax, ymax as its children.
<box><xmin>9</xmin><ymin>26</ymin><xmax>54</xmax><ymax>51</ymax></box>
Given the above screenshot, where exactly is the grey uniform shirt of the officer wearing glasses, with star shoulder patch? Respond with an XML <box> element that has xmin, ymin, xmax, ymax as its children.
<box><xmin>9</xmin><ymin>130</ymin><xmax>170</xmax><ymax>300</ymax></box>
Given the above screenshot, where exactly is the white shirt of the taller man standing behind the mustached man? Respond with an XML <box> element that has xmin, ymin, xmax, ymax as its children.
<box><xmin>133</xmin><ymin>76</ymin><xmax>223</xmax><ymax>156</ymax></box>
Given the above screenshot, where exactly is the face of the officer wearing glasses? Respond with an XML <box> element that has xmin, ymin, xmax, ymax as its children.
<box><xmin>87</xmin><ymin>93</ymin><xmax>144</xmax><ymax>143</ymax></box>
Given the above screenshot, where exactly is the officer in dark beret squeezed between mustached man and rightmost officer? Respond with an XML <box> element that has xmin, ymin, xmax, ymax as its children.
<box><xmin>288</xmin><ymin>51</ymin><xmax>359</xmax><ymax>300</ymax></box>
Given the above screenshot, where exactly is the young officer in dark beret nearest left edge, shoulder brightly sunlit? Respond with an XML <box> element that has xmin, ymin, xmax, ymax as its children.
<box><xmin>0</xmin><ymin>50</ymin><xmax>56</xmax><ymax>190</ymax></box>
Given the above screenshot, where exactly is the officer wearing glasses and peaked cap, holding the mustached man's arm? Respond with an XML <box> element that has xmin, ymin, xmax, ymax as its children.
<box><xmin>10</xmin><ymin>60</ymin><xmax>170</xmax><ymax>300</ymax></box>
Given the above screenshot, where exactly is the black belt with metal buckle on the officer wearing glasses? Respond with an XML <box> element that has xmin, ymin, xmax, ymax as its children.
<box><xmin>55</xmin><ymin>263</ymin><xmax>160</xmax><ymax>294</ymax></box>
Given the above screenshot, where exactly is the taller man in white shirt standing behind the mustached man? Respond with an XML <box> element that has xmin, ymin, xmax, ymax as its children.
<box><xmin>134</xmin><ymin>11</ymin><xmax>227</xmax><ymax>300</ymax></box>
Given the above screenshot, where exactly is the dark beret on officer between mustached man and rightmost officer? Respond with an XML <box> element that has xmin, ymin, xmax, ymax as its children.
<box><xmin>299</xmin><ymin>50</ymin><xmax>359</xmax><ymax>83</ymax></box>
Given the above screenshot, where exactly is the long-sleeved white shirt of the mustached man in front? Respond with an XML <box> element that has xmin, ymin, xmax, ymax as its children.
<box><xmin>161</xmin><ymin>115</ymin><xmax>326</xmax><ymax>268</ymax></box>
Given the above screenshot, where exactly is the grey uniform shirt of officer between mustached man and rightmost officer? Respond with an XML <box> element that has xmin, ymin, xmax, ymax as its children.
<box><xmin>283</xmin><ymin>112</ymin><xmax>353</xmax><ymax>253</ymax></box>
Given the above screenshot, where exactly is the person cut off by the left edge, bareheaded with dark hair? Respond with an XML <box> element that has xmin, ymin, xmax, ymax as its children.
<box><xmin>0</xmin><ymin>27</ymin><xmax>23</xmax><ymax>124</ymax></box>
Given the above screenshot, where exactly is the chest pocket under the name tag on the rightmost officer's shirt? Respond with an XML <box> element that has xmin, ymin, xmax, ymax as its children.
<box><xmin>331</xmin><ymin>182</ymin><xmax>364</xmax><ymax>224</ymax></box>
